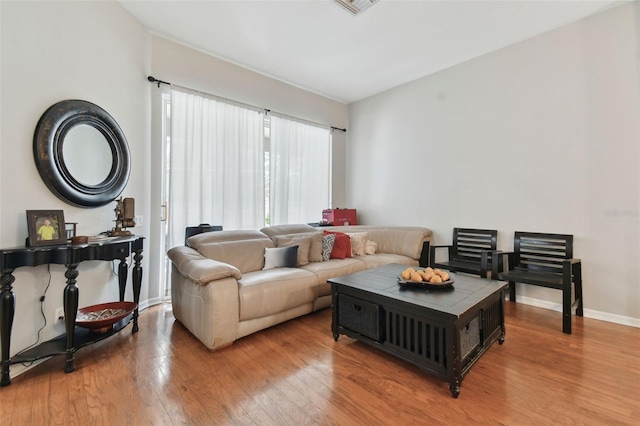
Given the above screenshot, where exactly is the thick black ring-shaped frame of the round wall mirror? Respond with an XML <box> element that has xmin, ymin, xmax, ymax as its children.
<box><xmin>33</xmin><ymin>99</ymin><xmax>131</xmax><ymax>207</ymax></box>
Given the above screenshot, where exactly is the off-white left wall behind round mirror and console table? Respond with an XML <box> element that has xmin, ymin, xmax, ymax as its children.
<box><xmin>0</xmin><ymin>1</ymin><xmax>152</xmax><ymax>366</ymax></box>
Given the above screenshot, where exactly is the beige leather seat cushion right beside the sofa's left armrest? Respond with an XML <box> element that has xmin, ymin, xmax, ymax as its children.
<box><xmin>238</xmin><ymin>268</ymin><xmax>318</xmax><ymax>321</ymax></box>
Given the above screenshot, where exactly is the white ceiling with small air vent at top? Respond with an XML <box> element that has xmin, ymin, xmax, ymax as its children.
<box><xmin>119</xmin><ymin>0</ymin><xmax>626</xmax><ymax>104</ymax></box>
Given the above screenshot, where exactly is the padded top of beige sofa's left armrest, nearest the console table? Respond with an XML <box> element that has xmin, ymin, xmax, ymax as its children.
<box><xmin>167</xmin><ymin>246</ymin><xmax>242</xmax><ymax>285</ymax></box>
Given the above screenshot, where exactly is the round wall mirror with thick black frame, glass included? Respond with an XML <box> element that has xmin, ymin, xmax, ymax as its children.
<box><xmin>33</xmin><ymin>99</ymin><xmax>131</xmax><ymax>207</ymax></box>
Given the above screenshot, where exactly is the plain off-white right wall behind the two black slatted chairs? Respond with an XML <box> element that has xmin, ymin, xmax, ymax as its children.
<box><xmin>346</xmin><ymin>2</ymin><xmax>640</xmax><ymax>327</ymax></box>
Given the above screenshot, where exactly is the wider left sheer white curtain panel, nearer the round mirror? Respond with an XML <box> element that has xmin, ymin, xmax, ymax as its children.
<box><xmin>169</xmin><ymin>89</ymin><xmax>265</xmax><ymax>247</ymax></box>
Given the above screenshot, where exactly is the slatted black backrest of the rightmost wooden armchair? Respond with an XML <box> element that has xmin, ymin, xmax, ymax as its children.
<box><xmin>513</xmin><ymin>232</ymin><xmax>573</xmax><ymax>274</ymax></box>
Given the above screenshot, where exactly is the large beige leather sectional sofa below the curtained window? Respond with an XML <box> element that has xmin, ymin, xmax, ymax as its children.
<box><xmin>168</xmin><ymin>225</ymin><xmax>431</xmax><ymax>350</ymax></box>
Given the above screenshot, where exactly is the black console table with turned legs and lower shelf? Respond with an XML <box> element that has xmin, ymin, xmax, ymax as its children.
<box><xmin>0</xmin><ymin>236</ymin><xmax>144</xmax><ymax>386</ymax></box>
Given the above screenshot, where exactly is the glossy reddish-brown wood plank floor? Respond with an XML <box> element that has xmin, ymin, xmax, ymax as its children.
<box><xmin>0</xmin><ymin>302</ymin><xmax>640</xmax><ymax>425</ymax></box>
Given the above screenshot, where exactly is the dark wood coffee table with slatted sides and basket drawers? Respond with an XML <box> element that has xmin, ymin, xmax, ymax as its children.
<box><xmin>329</xmin><ymin>265</ymin><xmax>508</xmax><ymax>398</ymax></box>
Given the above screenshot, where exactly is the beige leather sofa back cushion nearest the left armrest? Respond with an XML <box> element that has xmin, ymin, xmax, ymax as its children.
<box><xmin>189</xmin><ymin>230</ymin><xmax>275</xmax><ymax>274</ymax></box>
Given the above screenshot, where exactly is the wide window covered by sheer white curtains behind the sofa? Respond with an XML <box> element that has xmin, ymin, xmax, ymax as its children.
<box><xmin>168</xmin><ymin>89</ymin><xmax>331</xmax><ymax>247</ymax></box>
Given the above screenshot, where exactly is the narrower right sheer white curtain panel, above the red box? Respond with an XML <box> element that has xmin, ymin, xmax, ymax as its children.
<box><xmin>269</xmin><ymin>113</ymin><xmax>331</xmax><ymax>225</ymax></box>
